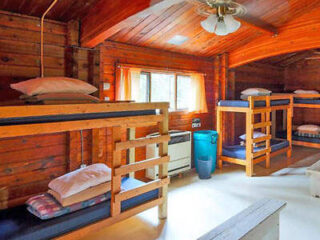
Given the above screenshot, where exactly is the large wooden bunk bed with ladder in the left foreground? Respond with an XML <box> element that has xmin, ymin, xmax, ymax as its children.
<box><xmin>0</xmin><ymin>103</ymin><xmax>170</xmax><ymax>240</ymax></box>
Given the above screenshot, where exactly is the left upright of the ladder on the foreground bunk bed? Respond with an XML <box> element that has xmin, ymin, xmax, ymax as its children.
<box><xmin>111</xmin><ymin>127</ymin><xmax>121</xmax><ymax>217</ymax></box>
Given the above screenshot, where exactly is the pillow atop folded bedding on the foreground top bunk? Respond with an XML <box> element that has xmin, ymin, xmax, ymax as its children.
<box><xmin>10</xmin><ymin>77</ymin><xmax>99</xmax><ymax>104</ymax></box>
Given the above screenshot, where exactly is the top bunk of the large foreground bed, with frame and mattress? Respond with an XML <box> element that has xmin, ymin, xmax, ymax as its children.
<box><xmin>0</xmin><ymin>102</ymin><xmax>168</xmax><ymax>138</ymax></box>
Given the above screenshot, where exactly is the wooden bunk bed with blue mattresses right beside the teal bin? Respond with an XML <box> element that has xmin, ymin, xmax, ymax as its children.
<box><xmin>217</xmin><ymin>94</ymin><xmax>293</xmax><ymax>176</ymax></box>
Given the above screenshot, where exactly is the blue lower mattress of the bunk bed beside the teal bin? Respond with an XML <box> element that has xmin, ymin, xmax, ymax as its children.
<box><xmin>222</xmin><ymin>139</ymin><xmax>289</xmax><ymax>160</ymax></box>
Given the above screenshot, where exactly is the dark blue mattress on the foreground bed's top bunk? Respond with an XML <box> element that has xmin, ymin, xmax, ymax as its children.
<box><xmin>0</xmin><ymin>110</ymin><xmax>156</xmax><ymax>126</ymax></box>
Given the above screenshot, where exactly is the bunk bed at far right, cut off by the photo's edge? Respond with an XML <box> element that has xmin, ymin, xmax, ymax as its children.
<box><xmin>277</xmin><ymin>94</ymin><xmax>320</xmax><ymax>149</ymax></box>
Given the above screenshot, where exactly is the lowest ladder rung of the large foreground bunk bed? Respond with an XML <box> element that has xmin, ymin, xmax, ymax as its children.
<box><xmin>115</xmin><ymin>177</ymin><xmax>170</xmax><ymax>202</ymax></box>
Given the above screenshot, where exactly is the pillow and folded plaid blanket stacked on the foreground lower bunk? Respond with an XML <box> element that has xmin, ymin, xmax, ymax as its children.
<box><xmin>26</xmin><ymin>163</ymin><xmax>111</xmax><ymax>220</ymax></box>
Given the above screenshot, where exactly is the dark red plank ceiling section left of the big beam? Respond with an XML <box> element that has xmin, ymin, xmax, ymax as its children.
<box><xmin>0</xmin><ymin>0</ymin><xmax>99</xmax><ymax>22</ymax></box>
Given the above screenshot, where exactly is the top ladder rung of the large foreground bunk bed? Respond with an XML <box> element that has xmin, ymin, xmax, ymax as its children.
<box><xmin>115</xmin><ymin>135</ymin><xmax>170</xmax><ymax>151</ymax></box>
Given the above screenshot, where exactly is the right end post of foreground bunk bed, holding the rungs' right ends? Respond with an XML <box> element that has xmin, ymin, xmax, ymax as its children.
<box><xmin>158</xmin><ymin>108</ymin><xmax>169</xmax><ymax>219</ymax></box>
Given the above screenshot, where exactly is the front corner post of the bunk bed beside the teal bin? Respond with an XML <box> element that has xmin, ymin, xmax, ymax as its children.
<box><xmin>246</xmin><ymin>96</ymin><xmax>254</xmax><ymax>177</ymax></box>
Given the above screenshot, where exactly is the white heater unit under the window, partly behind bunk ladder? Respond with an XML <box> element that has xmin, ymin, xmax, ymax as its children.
<box><xmin>146</xmin><ymin>130</ymin><xmax>191</xmax><ymax>179</ymax></box>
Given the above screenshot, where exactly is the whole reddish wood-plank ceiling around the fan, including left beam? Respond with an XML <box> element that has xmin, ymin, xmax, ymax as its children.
<box><xmin>0</xmin><ymin>0</ymin><xmax>320</xmax><ymax>60</ymax></box>
